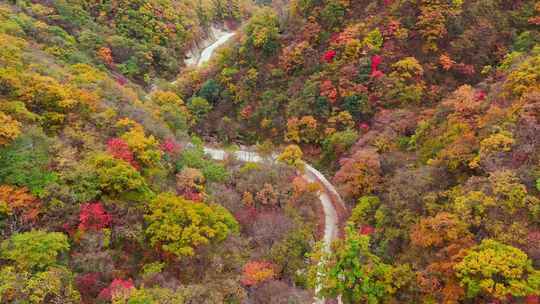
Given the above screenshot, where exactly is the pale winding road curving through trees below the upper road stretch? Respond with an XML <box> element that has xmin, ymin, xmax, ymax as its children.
<box><xmin>204</xmin><ymin>147</ymin><xmax>343</xmax><ymax>304</ymax></box>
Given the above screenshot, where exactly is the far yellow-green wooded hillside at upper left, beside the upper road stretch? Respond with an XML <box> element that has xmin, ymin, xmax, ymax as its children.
<box><xmin>4</xmin><ymin>0</ymin><xmax>254</xmax><ymax>84</ymax></box>
